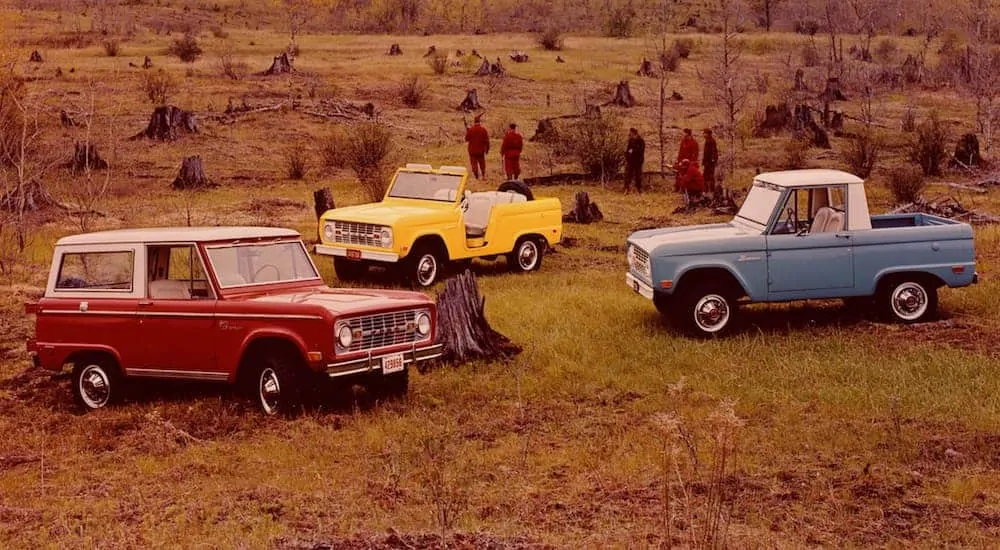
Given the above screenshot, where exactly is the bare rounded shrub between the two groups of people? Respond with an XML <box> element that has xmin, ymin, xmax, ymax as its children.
<box><xmin>560</xmin><ymin>114</ymin><xmax>625</xmax><ymax>180</ymax></box>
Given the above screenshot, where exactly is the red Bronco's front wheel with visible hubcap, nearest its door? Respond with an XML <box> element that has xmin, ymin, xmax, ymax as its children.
<box><xmin>245</xmin><ymin>353</ymin><xmax>304</xmax><ymax>416</ymax></box>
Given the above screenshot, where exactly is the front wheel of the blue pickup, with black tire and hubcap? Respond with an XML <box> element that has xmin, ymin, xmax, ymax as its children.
<box><xmin>668</xmin><ymin>283</ymin><xmax>739</xmax><ymax>338</ymax></box>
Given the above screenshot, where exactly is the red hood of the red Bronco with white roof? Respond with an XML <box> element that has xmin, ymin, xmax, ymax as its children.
<box><xmin>248</xmin><ymin>288</ymin><xmax>432</xmax><ymax>316</ymax></box>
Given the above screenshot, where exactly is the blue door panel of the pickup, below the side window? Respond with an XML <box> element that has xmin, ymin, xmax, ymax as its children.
<box><xmin>767</xmin><ymin>235</ymin><xmax>854</xmax><ymax>298</ymax></box>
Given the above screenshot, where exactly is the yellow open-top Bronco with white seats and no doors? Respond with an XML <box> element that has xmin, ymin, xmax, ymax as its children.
<box><xmin>316</xmin><ymin>164</ymin><xmax>562</xmax><ymax>287</ymax></box>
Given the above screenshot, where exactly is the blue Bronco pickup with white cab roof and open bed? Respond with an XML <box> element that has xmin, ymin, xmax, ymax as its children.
<box><xmin>625</xmin><ymin>170</ymin><xmax>978</xmax><ymax>337</ymax></box>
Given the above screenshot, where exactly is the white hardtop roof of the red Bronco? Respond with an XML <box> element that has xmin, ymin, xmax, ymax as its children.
<box><xmin>56</xmin><ymin>227</ymin><xmax>301</xmax><ymax>246</ymax></box>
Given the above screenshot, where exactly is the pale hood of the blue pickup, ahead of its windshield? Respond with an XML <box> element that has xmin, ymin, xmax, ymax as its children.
<box><xmin>628</xmin><ymin>222</ymin><xmax>761</xmax><ymax>255</ymax></box>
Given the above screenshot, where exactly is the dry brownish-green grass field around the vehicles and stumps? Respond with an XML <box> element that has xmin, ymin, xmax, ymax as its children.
<box><xmin>0</xmin><ymin>4</ymin><xmax>1000</xmax><ymax>548</ymax></box>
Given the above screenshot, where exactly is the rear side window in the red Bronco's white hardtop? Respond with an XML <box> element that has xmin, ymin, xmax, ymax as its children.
<box><xmin>56</xmin><ymin>251</ymin><xmax>135</xmax><ymax>292</ymax></box>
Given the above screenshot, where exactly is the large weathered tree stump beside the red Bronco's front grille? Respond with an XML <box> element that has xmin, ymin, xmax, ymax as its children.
<box><xmin>435</xmin><ymin>269</ymin><xmax>521</xmax><ymax>363</ymax></box>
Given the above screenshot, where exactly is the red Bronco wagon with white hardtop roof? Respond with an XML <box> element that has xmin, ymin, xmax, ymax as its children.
<box><xmin>26</xmin><ymin>227</ymin><xmax>441</xmax><ymax>415</ymax></box>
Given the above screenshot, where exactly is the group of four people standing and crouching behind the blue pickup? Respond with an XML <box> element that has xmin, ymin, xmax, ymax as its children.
<box><xmin>625</xmin><ymin>128</ymin><xmax>719</xmax><ymax>198</ymax></box>
